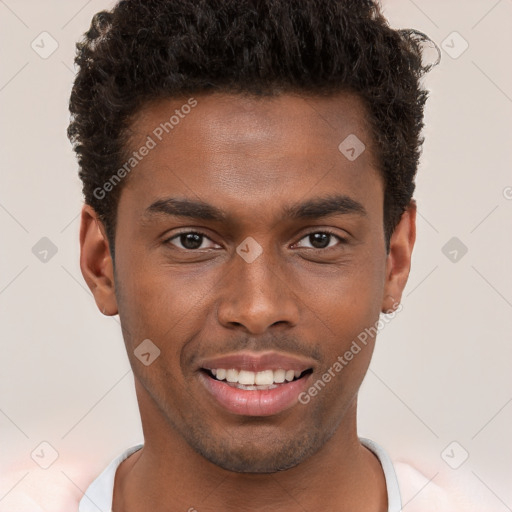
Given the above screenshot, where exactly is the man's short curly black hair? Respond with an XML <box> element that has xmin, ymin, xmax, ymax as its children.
<box><xmin>68</xmin><ymin>0</ymin><xmax>431</xmax><ymax>251</ymax></box>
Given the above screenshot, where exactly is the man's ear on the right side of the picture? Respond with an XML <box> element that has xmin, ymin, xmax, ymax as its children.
<box><xmin>382</xmin><ymin>199</ymin><xmax>416</xmax><ymax>313</ymax></box>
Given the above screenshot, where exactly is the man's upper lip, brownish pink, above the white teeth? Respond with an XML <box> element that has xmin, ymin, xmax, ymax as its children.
<box><xmin>199</xmin><ymin>352</ymin><xmax>313</xmax><ymax>372</ymax></box>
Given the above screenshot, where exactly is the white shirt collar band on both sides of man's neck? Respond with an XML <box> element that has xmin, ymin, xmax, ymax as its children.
<box><xmin>78</xmin><ymin>438</ymin><xmax>402</xmax><ymax>512</ymax></box>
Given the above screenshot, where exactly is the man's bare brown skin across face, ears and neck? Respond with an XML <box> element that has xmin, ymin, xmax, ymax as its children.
<box><xmin>80</xmin><ymin>93</ymin><xmax>416</xmax><ymax>512</ymax></box>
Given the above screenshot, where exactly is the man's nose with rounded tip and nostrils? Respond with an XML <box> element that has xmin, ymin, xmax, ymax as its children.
<box><xmin>217</xmin><ymin>245</ymin><xmax>299</xmax><ymax>335</ymax></box>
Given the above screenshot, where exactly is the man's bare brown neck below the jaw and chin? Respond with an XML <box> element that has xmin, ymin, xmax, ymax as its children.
<box><xmin>113</xmin><ymin>386</ymin><xmax>387</xmax><ymax>512</ymax></box>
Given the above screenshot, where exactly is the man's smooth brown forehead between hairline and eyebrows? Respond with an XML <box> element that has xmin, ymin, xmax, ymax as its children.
<box><xmin>121</xmin><ymin>93</ymin><xmax>382</xmax><ymax>224</ymax></box>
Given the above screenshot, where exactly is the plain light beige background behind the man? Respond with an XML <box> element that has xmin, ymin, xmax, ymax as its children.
<box><xmin>0</xmin><ymin>0</ymin><xmax>512</xmax><ymax>511</ymax></box>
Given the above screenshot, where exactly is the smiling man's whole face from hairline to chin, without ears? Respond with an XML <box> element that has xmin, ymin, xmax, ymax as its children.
<box><xmin>92</xmin><ymin>94</ymin><xmax>404</xmax><ymax>472</ymax></box>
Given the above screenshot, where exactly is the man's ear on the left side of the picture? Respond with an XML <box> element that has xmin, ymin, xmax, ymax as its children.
<box><xmin>80</xmin><ymin>204</ymin><xmax>118</xmax><ymax>316</ymax></box>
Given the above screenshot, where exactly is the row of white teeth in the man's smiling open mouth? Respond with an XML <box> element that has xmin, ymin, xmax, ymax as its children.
<box><xmin>201</xmin><ymin>368</ymin><xmax>313</xmax><ymax>391</ymax></box>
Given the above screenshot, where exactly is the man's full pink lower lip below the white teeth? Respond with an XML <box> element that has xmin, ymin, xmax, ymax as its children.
<box><xmin>199</xmin><ymin>372</ymin><xmax>311</xmax><ymax>416</ymax></box>
